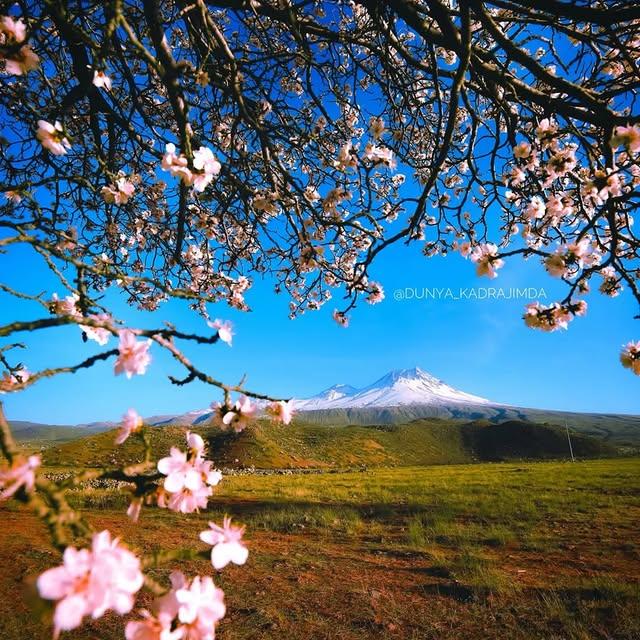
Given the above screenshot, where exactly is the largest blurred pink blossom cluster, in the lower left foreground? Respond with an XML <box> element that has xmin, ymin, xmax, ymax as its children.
<box><xmin>37</xmin><ymin>531</ymin><xmax>144</xmax><ymax>636</ymax></box>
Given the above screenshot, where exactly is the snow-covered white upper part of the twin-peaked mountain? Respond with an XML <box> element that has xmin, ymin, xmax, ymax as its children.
<box><xmin>295</xmin><ymin>367</ymin><xmax>491</xmax><ymax>411</ymax></box>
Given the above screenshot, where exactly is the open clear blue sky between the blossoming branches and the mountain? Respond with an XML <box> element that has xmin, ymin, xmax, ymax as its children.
<box><xmin>0</xmin><ymin>235</ymin><xmax>640</xmax><ymax>424</ymax></box>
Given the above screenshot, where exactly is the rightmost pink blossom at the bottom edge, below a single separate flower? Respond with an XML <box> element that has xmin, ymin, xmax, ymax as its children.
<box><xmin>176</xmin><ymin>576</ymin><xmax>226</xmax><ymax>640</ymax></box>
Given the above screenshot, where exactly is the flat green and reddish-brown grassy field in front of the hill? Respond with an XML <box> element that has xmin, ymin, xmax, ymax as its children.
<box><xmin>0</xmin><ymin>458</ymin><xmax>640</xmax><ymax>640</ymax></box>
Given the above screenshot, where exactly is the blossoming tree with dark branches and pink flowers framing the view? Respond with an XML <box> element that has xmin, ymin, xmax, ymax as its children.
<box><xmin>0</xmin><ymin>0</ymin><xmax>640</xmax><ymax>640</ymax></box>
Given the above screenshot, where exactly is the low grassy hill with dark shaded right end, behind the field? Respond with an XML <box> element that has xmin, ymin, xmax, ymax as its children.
<box><xmin>44</xmin><ymin>419</ymin><xmax>618</xmax><ymax>469</ymax></box>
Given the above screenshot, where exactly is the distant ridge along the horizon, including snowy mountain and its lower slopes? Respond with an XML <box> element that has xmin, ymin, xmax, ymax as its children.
<box><xmin>8</xmin><ymin>367</ymin><xmax>640</xmax><ymax>449</ymax></box>
